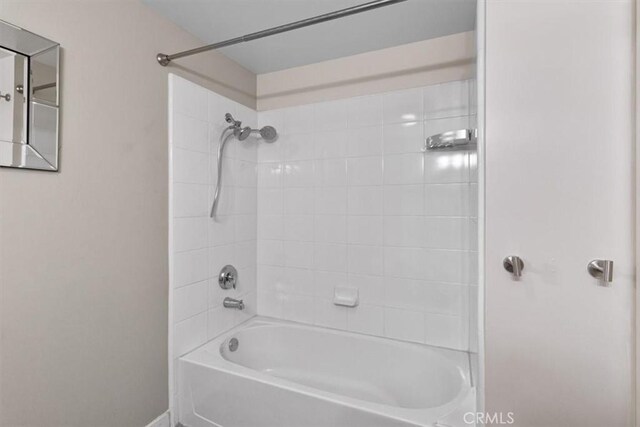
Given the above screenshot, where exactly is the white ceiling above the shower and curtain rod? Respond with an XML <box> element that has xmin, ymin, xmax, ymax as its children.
<box><xmin>144</xmin><ymin>0</ymin><xmax>476</xmax><ymax>74</ymax></box>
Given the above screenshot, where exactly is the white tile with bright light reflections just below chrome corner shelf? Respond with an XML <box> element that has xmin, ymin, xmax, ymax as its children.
<box><xmin>424</xmin><ymin>151</ymin><xmax>469</xmax><ymax>184</ymax></box>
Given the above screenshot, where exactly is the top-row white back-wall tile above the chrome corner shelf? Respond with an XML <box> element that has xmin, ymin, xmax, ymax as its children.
<box><xmin>424</xmin><ymin>80</ymin><xmax>469</xmax><ymax>119</ymax></box>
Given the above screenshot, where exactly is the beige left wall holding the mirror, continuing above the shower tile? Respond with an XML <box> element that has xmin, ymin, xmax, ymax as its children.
<box><xmin>0</xmin><ymin>0</ymin><xmax>256</xmax><ymax>427</ymax></box>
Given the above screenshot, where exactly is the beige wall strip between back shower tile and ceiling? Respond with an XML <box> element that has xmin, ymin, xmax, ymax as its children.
<box><xmin>258</xmin><ymin>32</ymin><xmax>476</xmax><ymax>110</ymax></box>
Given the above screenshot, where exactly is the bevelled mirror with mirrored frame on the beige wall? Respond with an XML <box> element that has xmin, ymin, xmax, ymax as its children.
<box><xmin>0</xmin><ymin>21</ymin><xmax>60</xmax><ymax>171</ymax></box>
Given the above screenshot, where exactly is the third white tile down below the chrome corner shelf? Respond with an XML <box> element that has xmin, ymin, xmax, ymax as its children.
<box><xmin>423</xmin><ymin>217</ymin><xmax>471</xmax><ymax>249</ymax></box>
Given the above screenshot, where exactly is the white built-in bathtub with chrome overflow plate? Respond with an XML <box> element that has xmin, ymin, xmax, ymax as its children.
<box><xmin>178</xmin><ymin>317</ymin><xmax>475</xmax><ymax>427</ymax></box>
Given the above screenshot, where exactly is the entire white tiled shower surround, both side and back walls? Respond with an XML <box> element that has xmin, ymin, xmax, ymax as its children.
<box><xmin>170</xmin><ymin>76</ymin><xmax>477</xmax><ymax>374</ymax></box>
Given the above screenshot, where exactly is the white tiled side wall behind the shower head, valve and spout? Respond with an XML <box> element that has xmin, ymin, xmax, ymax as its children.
<box><xmin>169</xmin><ymin>75</ymin><xmax>257</xmax><ymax>412</ymax></box>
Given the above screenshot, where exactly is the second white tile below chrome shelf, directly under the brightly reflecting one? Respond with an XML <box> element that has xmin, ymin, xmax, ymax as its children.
<box><xmin>424</xmin><ymin>184</ymin><xmax>469</xmax><ymax>216</ymax></box>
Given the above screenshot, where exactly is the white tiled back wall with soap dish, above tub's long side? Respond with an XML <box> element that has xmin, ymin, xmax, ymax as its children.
<box><xmin>258</xmin><ymin>81</ymin><xmax>477</xmax><ymax>350</ymax></box>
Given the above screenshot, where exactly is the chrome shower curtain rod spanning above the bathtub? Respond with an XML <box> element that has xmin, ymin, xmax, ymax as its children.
<box><xmin>156</xmin><ymin>0</ymin><xmax>407</xmax><ymax>67</ymax></box>
